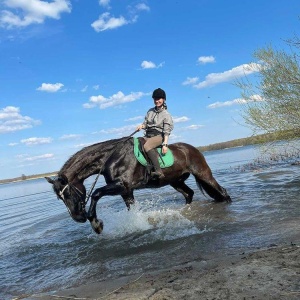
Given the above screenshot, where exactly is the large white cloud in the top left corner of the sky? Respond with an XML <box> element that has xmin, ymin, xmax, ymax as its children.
<box><xmin>0</xmin><ymin>0</ymin><xmax>71</xmax><ymax>28</ymax></box>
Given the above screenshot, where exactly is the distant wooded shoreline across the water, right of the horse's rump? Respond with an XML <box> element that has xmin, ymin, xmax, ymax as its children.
<box><xmin>197</xmin><ymin>133</ymin><xmax>299</xmax><ymax>152</ymax></box>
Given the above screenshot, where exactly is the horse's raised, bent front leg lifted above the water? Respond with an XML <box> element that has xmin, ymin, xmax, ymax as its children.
<box><xmin>87</xmin><ymin>182</ymin><xmax>126</xmax><ymax>234</ymax></box>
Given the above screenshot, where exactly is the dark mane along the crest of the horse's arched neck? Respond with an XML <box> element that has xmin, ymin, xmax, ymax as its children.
<box><xmin>58</xmin><ymin>137</ymin><xmax>128</xmax><ymax>175</ymax></box>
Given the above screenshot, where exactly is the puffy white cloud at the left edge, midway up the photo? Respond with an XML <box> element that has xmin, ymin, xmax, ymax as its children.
<box><xmin>0</xmin><ymin>106</ymin><xmax>40</xmax><ymax>134</ymax></box>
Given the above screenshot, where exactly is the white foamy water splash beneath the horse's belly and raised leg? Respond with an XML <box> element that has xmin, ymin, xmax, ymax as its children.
<box><xmin>95</xmin><ymin>196</ymin><xmax>201</xmax><ymax>246</ymax></box>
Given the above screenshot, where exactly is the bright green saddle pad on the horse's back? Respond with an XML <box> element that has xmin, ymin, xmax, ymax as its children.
<box><xmin>133</xmin><ymin>138</ymin><xmax>174</xmax><ymax>169</ymax></box>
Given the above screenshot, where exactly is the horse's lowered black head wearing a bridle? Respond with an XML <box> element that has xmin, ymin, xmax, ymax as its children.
<box><xmin>45</xmin><ymin>175</ymin><xmax>87</xmax><ymax>223</ymax></box>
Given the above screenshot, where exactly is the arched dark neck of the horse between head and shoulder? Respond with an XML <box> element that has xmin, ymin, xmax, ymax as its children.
<box><xmin>59</xmin><ymin>142</ymin><xmax>121</xmax><ymax>182</ymax></box>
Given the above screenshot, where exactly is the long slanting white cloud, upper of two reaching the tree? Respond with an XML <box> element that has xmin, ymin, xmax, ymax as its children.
<box><xmin>194</xmin><ymin>63</ymin><xmax>260</xmax><ymax>89</ymax></box>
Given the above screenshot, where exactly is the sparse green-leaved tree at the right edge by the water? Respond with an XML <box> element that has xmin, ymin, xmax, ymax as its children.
<box><xmin>235</xmin><ymin>42</ymin><xmax>300</xmax><ymax>139</ymax></box>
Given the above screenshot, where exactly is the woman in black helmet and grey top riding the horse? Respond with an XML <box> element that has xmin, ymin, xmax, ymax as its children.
<box><xmin>137</xmin><ymin>88</ymin><xmax>174</xmax><ymax>178</ymax></box>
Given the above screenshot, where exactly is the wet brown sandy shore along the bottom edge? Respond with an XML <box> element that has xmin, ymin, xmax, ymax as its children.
<box><xmin>28</xmin><ymin>244</ymin><xmax>300</xmax><ymax>300</ymax></box>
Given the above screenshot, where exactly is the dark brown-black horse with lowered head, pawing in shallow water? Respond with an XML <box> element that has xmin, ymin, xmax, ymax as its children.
<box><xmin>45</xmin><ymin>136</ymin><xmax>231</xmax><ymax>234</ymax></box>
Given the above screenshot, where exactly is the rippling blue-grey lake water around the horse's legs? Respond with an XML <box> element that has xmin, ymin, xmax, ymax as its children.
<box><xmin>0</xmin><ymin>146</ymin><xmax>300</xmax><ymax>299</ymax></box>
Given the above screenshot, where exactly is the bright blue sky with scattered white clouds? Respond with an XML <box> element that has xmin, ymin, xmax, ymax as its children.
<box><xmin>0</xmin><ymin>0</ymin><xmax>300</xmax><ymax>179</ymax></box>
